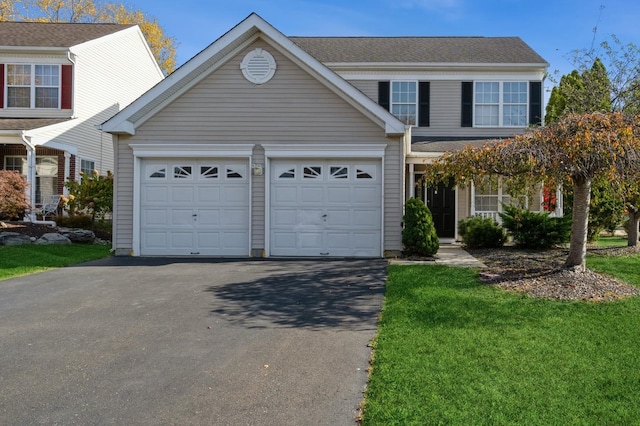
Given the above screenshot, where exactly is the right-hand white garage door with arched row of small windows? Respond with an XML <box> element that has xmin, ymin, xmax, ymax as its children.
<box><xmin>270</xmin><ymin>160</ymin><xmax>382</xmax><ymax>257</ymax></box>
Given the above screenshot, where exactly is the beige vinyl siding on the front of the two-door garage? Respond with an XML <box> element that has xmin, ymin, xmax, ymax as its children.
<box><xmin>117</xmin><ymin>40</ymin><xmax>404</xmax><ymax>254</ymax></box>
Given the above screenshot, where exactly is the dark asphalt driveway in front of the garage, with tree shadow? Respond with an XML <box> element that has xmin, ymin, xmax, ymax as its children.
<box><xmin>0</xmin><ymin>257</ymin><xmax>386</xmax><ymax>426</ymax></box>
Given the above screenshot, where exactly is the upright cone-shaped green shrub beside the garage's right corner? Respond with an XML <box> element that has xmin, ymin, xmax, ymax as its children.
<box><xmin>402</xmin><ymin>198</ymin><xmax>440</xmax><ymax>256</ymax></box>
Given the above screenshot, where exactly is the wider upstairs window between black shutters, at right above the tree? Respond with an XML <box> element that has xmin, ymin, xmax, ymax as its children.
<box><xmin>474</xmin><ymin>81</ymin><xmax>529</xmax><ymax>127</ymax></box>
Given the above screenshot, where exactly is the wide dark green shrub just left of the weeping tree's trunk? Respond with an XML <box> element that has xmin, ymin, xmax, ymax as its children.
<box><xmin>499</xmin><ymin>205</ymin><xmax>571</xmax><ymax>249</ymax></box>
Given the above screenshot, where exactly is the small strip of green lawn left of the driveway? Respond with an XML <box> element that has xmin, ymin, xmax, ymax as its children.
<box><xmin>0</xmin><ymin>244</ymin><xmax>111</xmax><ymax>280</ymax></box>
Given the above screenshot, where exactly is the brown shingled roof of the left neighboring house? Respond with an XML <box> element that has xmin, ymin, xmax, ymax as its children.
<box><xmin>0</xmin><ymin>22</ymin><xmax>135</xmax><ymax>48</ymax></box>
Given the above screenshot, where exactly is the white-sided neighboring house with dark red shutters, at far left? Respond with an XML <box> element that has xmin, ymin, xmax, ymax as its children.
<box><xmin>0</xmin><ymin>22</ymin><xmax>163</xmax><ymax>213</ymax></box>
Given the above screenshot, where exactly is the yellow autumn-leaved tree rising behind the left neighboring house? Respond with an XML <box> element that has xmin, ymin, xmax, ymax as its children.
<box><xmin>0</xmin><ymin>0</ymin><xmax>176</xmax><ymax>74</ymax></box>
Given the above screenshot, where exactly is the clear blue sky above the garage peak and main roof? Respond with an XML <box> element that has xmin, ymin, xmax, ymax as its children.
<box><xmin>129</xmin><ymin>0</ymin><xmax>640</xmax><ymax>91</ymax></box>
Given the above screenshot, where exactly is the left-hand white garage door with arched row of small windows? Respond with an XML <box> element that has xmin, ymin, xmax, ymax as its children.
<box><xmin>140</xmin><ymin>160</ymin><xmax>249</xmax><ymax>256</ymax></box>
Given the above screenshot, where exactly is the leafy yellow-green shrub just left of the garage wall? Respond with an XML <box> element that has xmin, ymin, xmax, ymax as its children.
<box><xmin>63</xmin><ymin>170</ymin><xmax>113</xmax><ymax>221</ymax></box>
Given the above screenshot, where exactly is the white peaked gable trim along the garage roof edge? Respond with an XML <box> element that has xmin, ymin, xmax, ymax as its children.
<box><xmin>101</xmin><ymin>13</ymin><xmax>406</xmax><ymax>135</ymax></box>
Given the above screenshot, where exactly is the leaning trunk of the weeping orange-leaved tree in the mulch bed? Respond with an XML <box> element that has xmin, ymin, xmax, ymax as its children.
<box><xmin>564</xmin><ymin>177</ymin><xmax>591</xmax><ymax>271</ymax></box>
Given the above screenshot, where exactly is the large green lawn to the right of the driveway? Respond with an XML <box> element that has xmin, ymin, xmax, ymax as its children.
<box><xmin>363</xmin><ymin>256</ymin><xmax>640</xmax><ymax>426</ymax></box>
